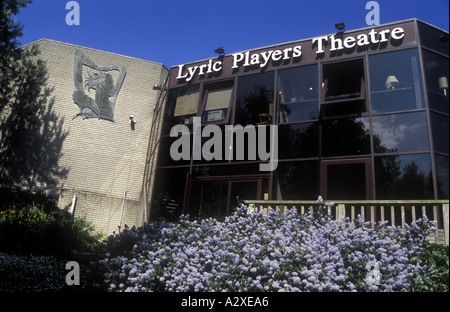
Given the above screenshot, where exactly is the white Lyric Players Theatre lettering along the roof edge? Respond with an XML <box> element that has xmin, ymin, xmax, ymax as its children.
<box><xmin>172</xmin><ymin>24</ymin><xmax>415</xmax><ymax>83</ymax></box>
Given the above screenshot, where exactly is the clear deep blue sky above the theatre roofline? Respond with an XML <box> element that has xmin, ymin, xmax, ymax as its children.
<box><xmin>17</xmin><ymin>0</ymin><xmax>449</xmax><ymax>67</ymax></box>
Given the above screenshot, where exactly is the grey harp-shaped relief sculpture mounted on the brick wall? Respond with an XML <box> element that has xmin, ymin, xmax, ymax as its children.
<box><xmin>73</xmin><ymin>50</ymin><xmax>126</xmax><ymax>122</ymax></box>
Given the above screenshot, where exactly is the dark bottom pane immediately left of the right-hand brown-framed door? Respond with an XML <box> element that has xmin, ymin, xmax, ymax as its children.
<box><xmin>273</xmin><ymin>161</ymin><xmax>319</xmax><ymax>200</ymax></box>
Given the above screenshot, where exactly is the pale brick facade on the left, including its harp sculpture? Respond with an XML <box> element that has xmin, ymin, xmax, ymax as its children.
<box><xmin>2</xmin><ymin>39</ymin><xmax>168</xmax><ymax>234</ymax></box>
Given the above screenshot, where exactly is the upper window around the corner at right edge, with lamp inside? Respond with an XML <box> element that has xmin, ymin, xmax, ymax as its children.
<box><xmin>423</xmin><ymin>50</ymin><xmax>449</xmax><ymax>114</ymax></box>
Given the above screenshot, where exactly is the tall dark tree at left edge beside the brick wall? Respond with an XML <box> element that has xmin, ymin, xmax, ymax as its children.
<box><xmin>0</xmin><ymin>0</ymin><xmax>66</xmax><ymax>190</ymax></box>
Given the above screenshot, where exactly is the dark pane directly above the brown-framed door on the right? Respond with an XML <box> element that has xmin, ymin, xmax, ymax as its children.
<box><xmin>322</xmin><ymin>118</ymin><xmax>370</xmax><ymax>156</ymax></box>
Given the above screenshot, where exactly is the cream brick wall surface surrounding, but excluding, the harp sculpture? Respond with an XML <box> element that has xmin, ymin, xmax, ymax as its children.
<box><xmin>17</xmin><ymin>39</ymin><xmax>168</xmax><ymax>234</ymax></box>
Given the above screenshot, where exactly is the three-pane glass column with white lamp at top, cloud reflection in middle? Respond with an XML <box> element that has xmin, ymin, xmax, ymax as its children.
<box><xmin>369</xmin><ymin>49</ymin><xmax>434</xmax><ymax>199</ymax></box>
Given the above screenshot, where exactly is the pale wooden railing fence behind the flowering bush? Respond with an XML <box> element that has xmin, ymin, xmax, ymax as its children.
<box><xmin>244</xmin><ymin>200</ymin><xmax>449</xmax><ymax>245</ymax></box>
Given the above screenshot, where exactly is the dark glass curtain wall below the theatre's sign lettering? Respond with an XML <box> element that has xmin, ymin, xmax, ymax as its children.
<box><xmin>152</xmin><ymin>25</ymin><xmax>449</xmax><ymax>222</ymax></box>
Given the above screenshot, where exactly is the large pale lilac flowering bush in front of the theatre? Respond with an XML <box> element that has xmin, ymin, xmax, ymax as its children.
<box><xmin>93</xmin><ymin>202</ymin><xmax>448</xmax><ymax>292</ymax></box>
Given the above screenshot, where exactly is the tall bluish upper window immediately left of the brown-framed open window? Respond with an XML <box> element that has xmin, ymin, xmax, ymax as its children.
<box><xmin>277</xmin><ymin>65</ymin><xmax>318</xmax><ymax>123</ymax></box>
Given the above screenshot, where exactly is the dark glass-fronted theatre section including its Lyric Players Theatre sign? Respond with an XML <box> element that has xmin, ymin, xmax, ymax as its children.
<box><xmin>149</xmin><ymin>19</ymin><xmax>449</xmax><ymax>220</ymax></box>
